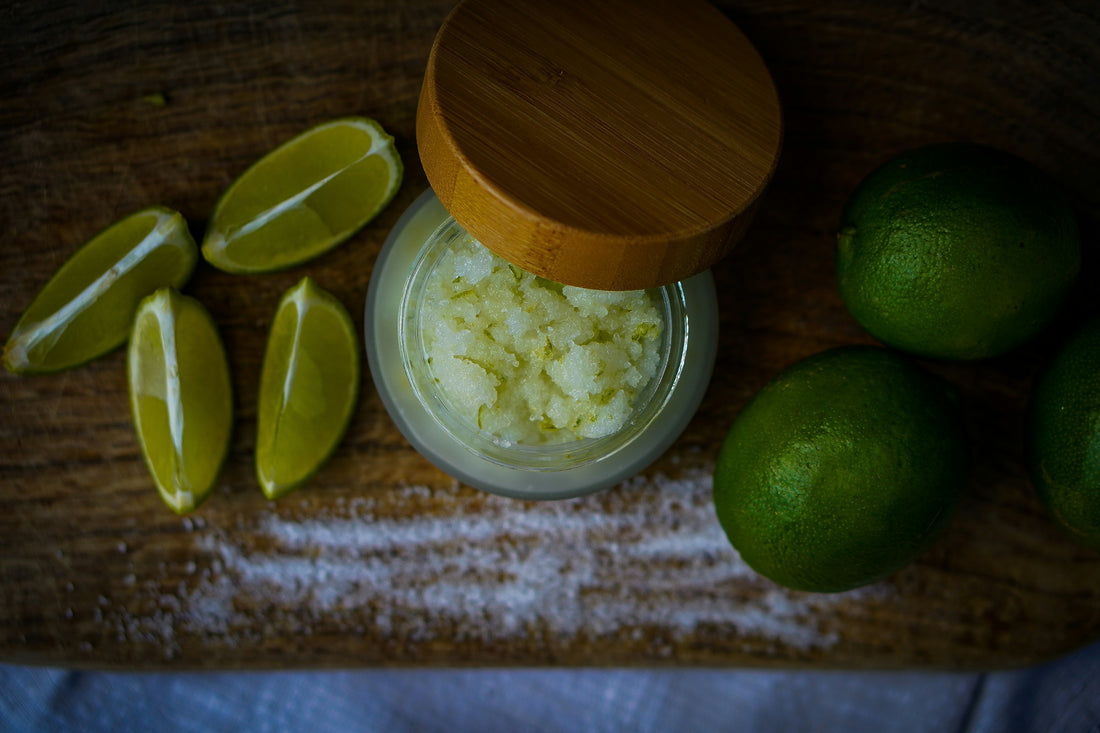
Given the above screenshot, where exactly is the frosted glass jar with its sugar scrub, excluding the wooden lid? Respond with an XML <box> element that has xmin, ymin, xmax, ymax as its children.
<box><xmin>366</xmin><ymin>190</ymin><xmax>717</xmax><ymax>499</ymax></box>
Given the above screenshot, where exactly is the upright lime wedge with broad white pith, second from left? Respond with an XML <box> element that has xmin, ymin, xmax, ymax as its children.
<box><xmin>128</xmin><ymin>288</ymin><xmax>233</xmax><ymax>514</ymax></box>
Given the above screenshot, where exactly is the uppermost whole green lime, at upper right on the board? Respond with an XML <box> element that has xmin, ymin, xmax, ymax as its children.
<box><xmin>836</xmin><ymin>143</ymin><xmax>1080</xmax><ymax>359</ymax></box>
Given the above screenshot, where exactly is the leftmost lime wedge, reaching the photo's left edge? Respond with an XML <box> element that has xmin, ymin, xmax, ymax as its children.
<box><xmin>3</xmin><ymin>206</ymin><xmax>198</xmax><ymax>374</ymax></box>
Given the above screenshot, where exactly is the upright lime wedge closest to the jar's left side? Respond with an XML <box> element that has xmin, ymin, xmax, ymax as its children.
<box><xmin>256</xmin><ymin>277</ymin><xmax>360</xmax><ymax>499</ymax></box>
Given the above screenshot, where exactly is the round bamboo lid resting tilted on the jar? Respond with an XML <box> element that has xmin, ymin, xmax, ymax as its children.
<box><xmin>417</xmin><ymin>0</ymin><xmax>782</xmax><ymax>289</ymax></box>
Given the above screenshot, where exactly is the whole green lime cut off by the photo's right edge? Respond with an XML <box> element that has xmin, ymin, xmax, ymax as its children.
<box><xmin>1026</xmin><ymin>318</ymin><xmax>1100</xmax><ymax>551</ymax></box>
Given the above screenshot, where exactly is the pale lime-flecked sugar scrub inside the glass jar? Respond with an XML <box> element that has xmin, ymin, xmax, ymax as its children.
<box><xmin>420</xmin><ymin>234</ymin><xmax>661</xmax><ymax>445</ymax></box>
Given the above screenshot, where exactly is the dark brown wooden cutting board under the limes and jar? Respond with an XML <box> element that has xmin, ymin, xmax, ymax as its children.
<box><xmin>0</xmin><ymin>0</ymin><xmax>1100</xmax><ymax>668</ymax></box>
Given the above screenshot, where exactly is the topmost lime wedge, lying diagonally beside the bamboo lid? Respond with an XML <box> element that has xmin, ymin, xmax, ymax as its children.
<box><xmin>202</xmin><ymin>118</ymin><xmax>404</xmax><ymax>273</ymax></box>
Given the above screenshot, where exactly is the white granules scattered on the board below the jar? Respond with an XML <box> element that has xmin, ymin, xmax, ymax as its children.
<box><xmin>135</xmin><ymin>470</ymin><xmax>889</xmax><ymax>654</ymax></box>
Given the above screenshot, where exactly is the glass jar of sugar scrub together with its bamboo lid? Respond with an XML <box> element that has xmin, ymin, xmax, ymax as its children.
<box><xmin>365</xmin><ymin>0</ymin><xmax>781</xmax><ymax>499</ymax></box>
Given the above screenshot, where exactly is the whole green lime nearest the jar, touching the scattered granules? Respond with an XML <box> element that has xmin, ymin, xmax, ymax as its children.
<box><xmin>714</xmin><ymin>346</ymin><xmax>970</xmax><ymax>592</ymax></box>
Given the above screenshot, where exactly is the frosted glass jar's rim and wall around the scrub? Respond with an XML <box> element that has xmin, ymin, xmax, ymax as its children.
<box><xmin>364</xmin><ymin>190</ymin><xmax>718</xmax><ymax>500</ymax></box>
